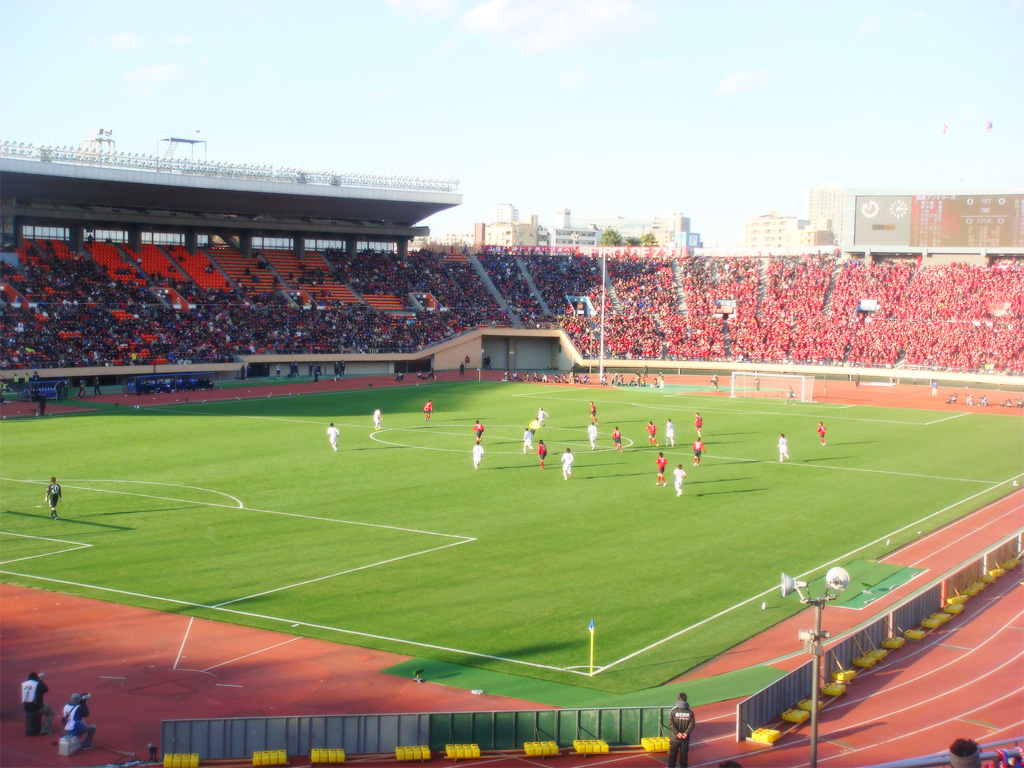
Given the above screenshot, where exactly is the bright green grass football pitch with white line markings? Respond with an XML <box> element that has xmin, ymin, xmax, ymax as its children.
<box><xmin>0</xmin><ymin>382</ymin><xmax>1024</xmax><ymax>692</ymax></box>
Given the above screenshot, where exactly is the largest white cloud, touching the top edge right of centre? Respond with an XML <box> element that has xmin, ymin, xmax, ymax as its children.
<box><xmin>459</xmin><ymin>0</ymin><xmax>650</xmax><ymax>53</ymax></box>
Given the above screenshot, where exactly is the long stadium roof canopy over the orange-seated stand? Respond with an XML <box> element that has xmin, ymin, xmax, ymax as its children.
<box><xmin>0</xmin><ymin>150</ymin><xmax>462</xmax><ymax>240</ymax></box>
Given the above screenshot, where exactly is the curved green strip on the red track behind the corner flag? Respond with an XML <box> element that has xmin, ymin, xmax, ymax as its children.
<box><xmin>384</xmin><ymin>658</ymin><xmax>785</xmax><ymax>709</ymax></box>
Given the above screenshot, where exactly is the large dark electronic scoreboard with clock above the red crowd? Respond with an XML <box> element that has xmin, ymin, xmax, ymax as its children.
<box><xmin>854</xmin><ymin>193</ymin><xmax>1024</xmax><ymax>248</ymax></box>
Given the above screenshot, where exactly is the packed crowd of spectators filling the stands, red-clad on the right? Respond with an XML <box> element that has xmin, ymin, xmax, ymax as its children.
<box><xmin>0</xmin><ymin>241</ymin><xmax>1024</xmax><ymax>373</ymax></box>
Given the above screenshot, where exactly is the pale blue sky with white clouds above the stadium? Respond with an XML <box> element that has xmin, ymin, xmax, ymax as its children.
<box><xmin>0</xmin><ymin>0</ymin><xmax>1024</xmax><ymax>247</ymax></box>
